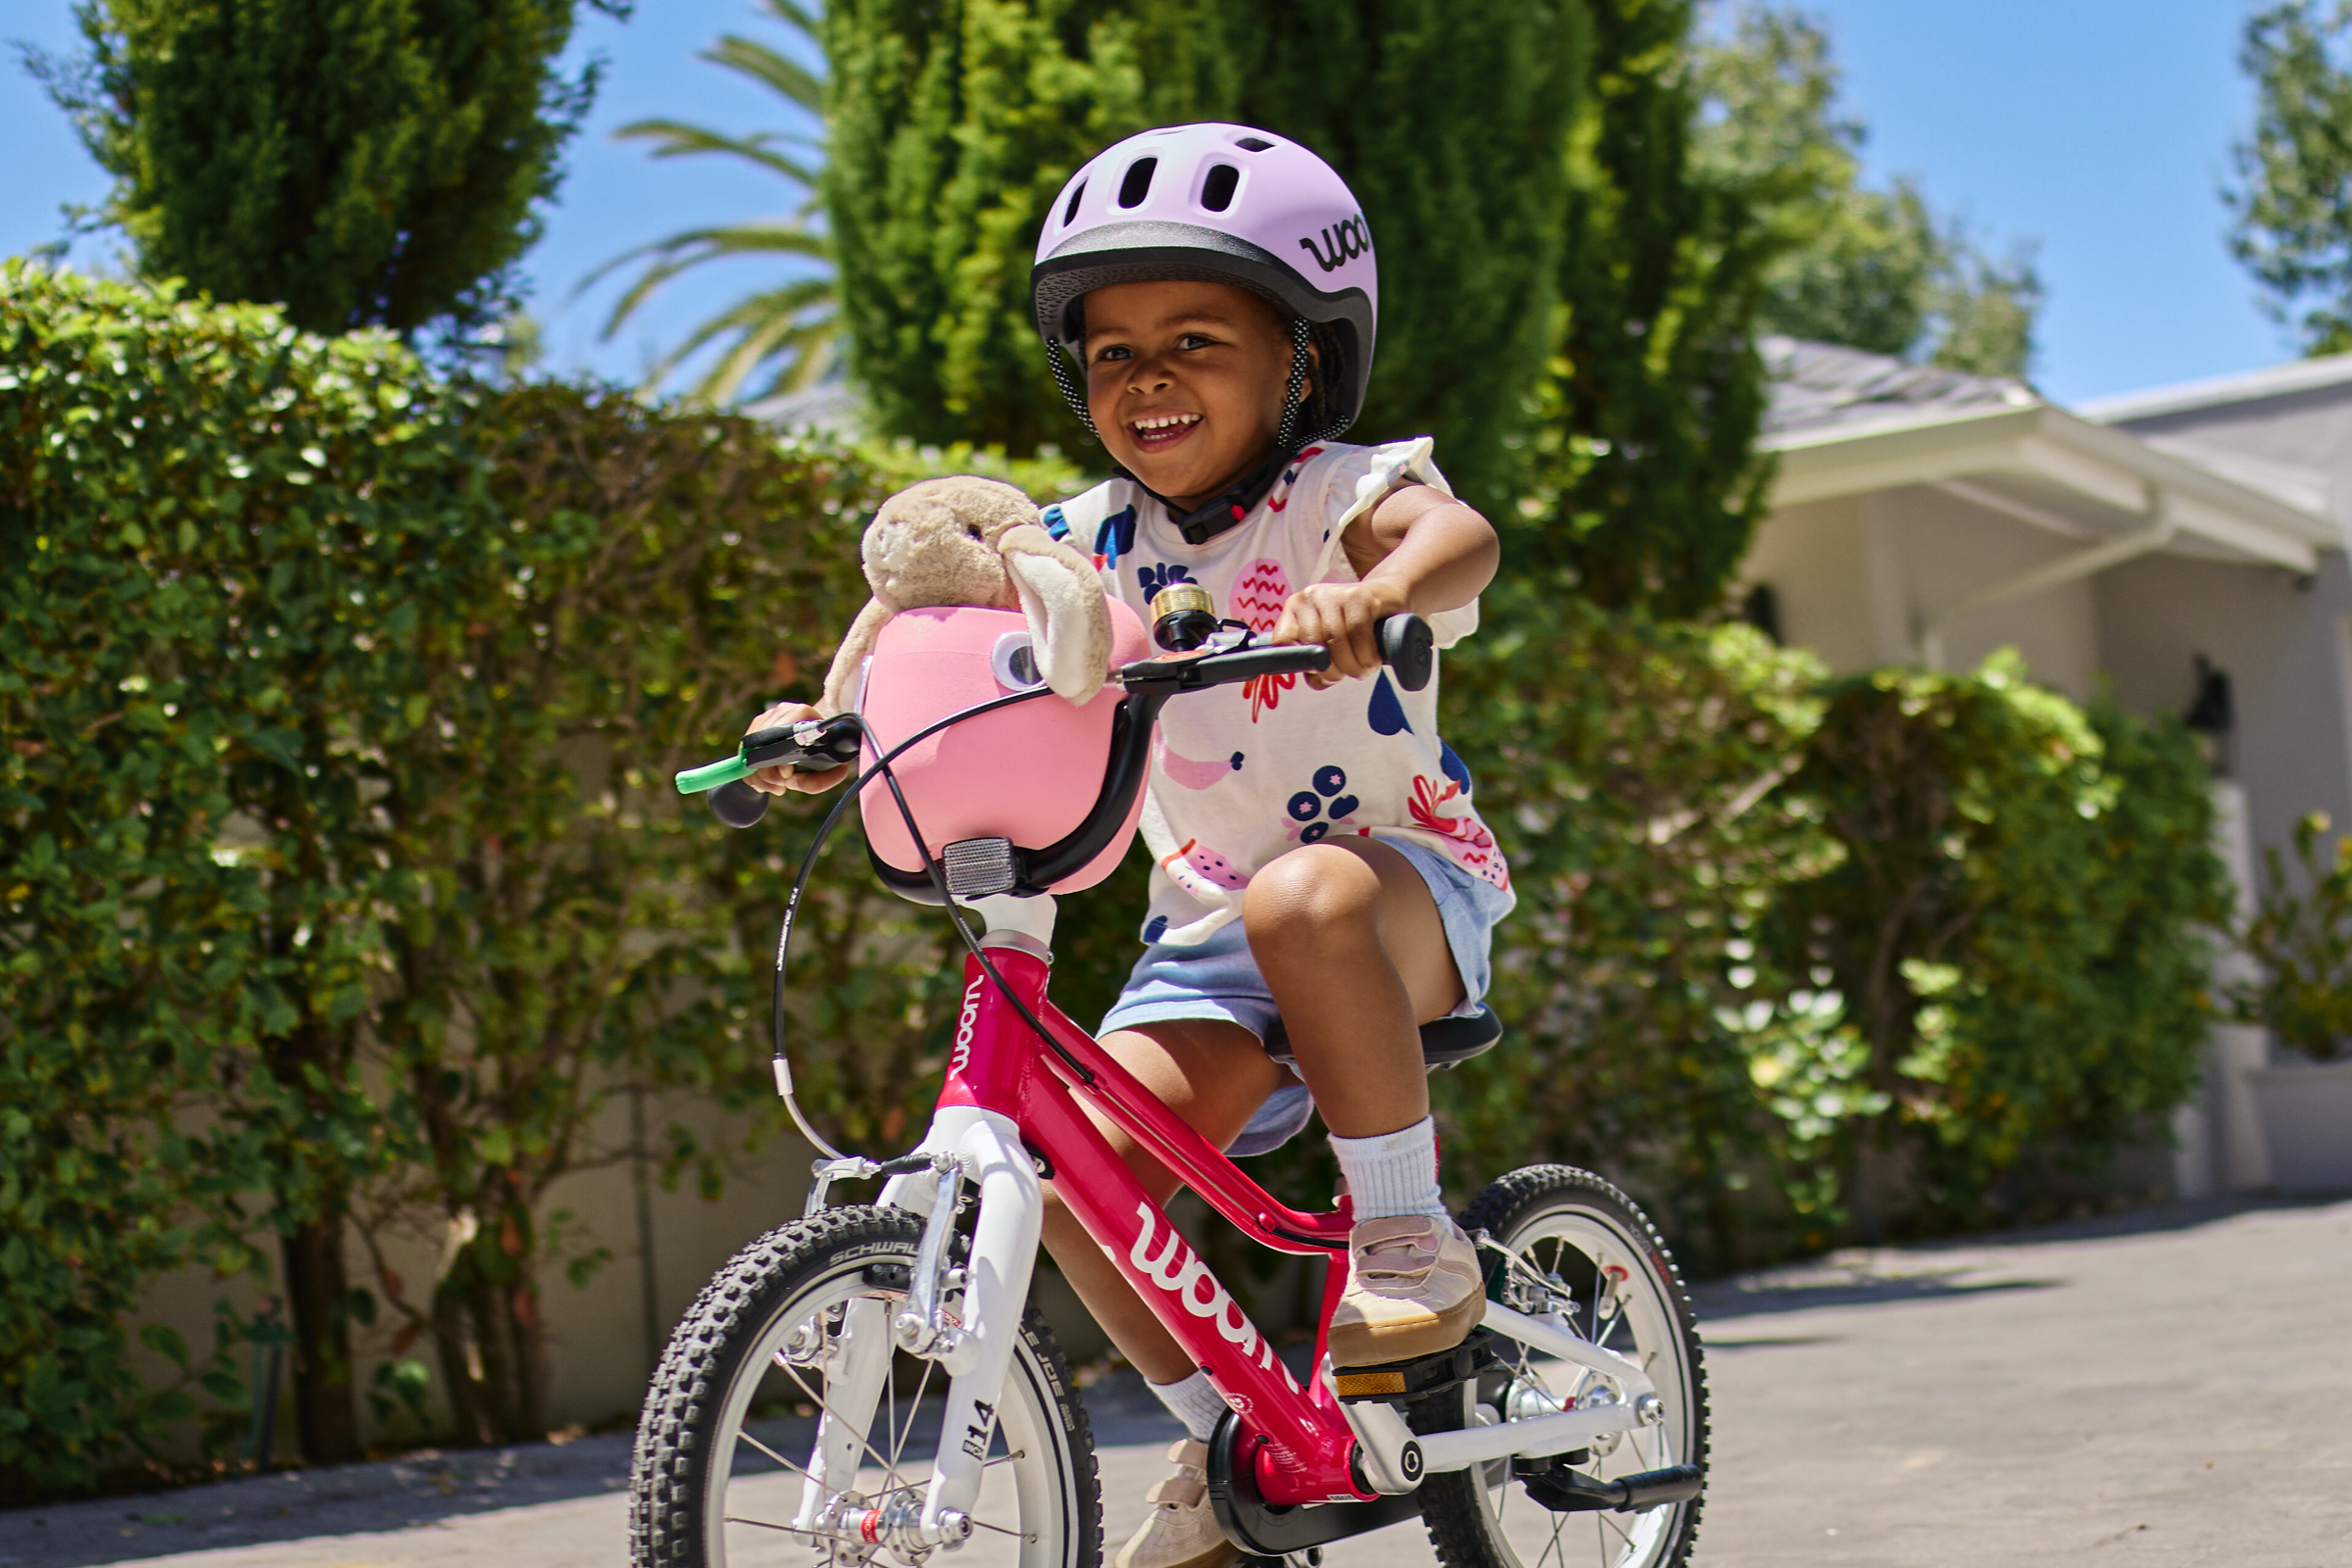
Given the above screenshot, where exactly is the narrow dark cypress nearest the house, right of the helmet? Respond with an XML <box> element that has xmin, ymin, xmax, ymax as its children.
<box><xmin>1498</xmin><ymin>0</ymin><xmax>1783</xmax><ymax>615</ymax></box>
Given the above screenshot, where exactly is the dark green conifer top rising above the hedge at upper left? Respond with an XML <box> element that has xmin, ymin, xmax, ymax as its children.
<box><xmin>45</xmin><ymin>0</ymin><xmax>628</xmax><ymax>334</ymax></box>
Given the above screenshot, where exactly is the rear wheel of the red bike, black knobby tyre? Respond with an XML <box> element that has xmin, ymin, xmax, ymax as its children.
<box><xmin>1406</xmin><ymin>1166</ymin><xmax>1707</xmax><ymax>1568</ymax></box>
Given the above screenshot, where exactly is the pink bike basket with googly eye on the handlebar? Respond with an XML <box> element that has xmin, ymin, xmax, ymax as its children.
<box><xmin>858</xmin><ymin>600</ymin><xmax>1151</xmax><ymax>894</ymax></box>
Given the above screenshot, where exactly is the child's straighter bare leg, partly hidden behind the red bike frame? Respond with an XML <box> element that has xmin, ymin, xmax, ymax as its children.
<box><xmin>1045</xmin><ymin>1018</ymin><xmax>1287</xmax><ymax>1385</ymax></box>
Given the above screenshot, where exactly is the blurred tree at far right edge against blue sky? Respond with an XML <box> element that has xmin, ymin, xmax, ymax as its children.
<box><xmin>2223</xmin><ymin>0</ymin><xmax>2352</xmax><ymax>355</ymax></box>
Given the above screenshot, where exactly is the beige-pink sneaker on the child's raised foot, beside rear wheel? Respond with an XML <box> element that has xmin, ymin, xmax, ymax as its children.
<box><xmin>1329</xmin><ymin>1213</ymin><xmax>1487</xmax><ymax>1366</ymax></box>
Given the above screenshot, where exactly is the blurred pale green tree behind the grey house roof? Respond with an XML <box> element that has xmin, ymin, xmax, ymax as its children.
<box><xmin>1693</xmin><ymin>7</ymin><xmax>2041</xmax><ymax>376</ymax></box>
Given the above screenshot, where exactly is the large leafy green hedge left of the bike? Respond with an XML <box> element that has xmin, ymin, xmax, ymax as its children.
<box><xmin>0</xmin><ymin>264</ymin><xmax>1091</xmax><ymax>1495</ymax></box>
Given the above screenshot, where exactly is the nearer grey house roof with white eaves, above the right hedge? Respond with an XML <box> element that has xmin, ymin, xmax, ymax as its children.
<box><xmin>1759</xmin><ymin>338</ymin><xmax>2342</xmax><ymax>571</ymax></box>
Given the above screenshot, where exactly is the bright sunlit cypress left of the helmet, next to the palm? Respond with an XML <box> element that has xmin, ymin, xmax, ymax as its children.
<box><xmin>823</xmin><ymin>0</ymin><xmax>1235</xmax><ymax>452</ymax></box>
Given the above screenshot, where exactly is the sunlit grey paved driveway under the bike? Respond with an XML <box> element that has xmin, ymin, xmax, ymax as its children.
<box><xmin>0</xmin><ymin>1203</ymin><xmax>2352</xmax><ymax>1568</ymax></box>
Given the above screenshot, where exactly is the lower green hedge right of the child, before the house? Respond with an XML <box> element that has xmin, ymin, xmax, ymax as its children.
<box><xmin>1440</xmin><ymin>625</ymin><xmax>2228</xmax><ymax>1267</ymax></box>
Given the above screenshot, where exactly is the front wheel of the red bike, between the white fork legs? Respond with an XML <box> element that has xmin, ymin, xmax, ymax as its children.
<box><xmin>628</xmin><ymin>1208</ymin><xmax>1103</xmax><ymax>1568</ymax></box>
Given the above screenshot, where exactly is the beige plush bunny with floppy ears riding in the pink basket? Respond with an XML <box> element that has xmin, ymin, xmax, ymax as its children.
<box><xmin>818</xmin><ymin>475</ymin><xmax>1110</xmax><ymax>717</ymax></box>
